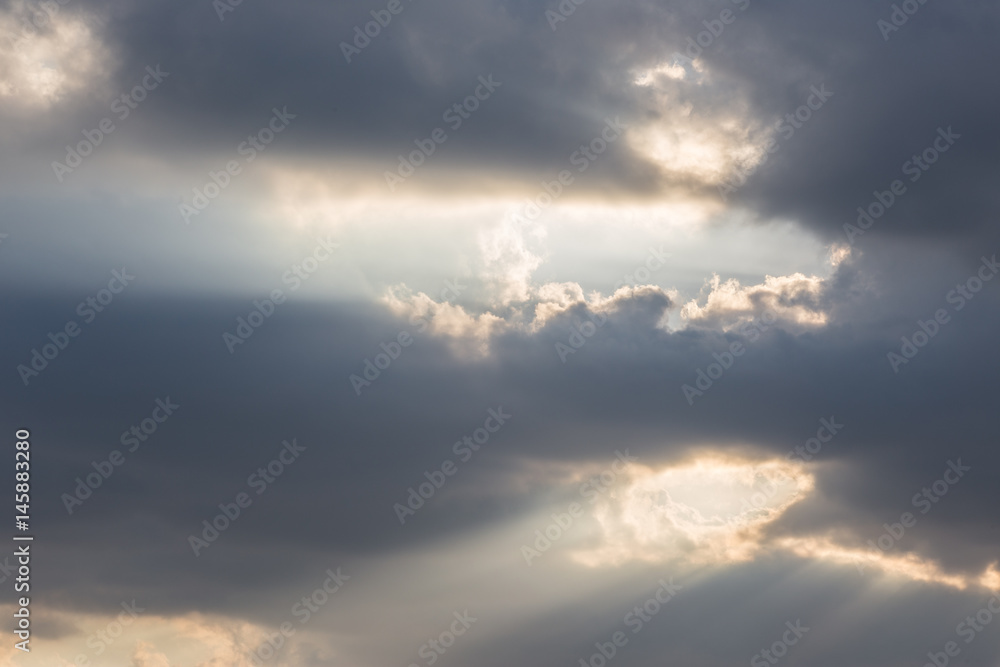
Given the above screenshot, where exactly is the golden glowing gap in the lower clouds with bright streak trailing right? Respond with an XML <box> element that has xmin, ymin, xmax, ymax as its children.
<box><xmin>572</xmin><ymin>455</ymin><xmax>1000</xmax><ymax>591</ymax></box>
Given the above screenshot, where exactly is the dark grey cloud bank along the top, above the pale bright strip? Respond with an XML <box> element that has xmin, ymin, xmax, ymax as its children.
<box><xmin>5</xmin><ymin>2</ymin><xmax>996</xmax><ymax>228</ymax></box>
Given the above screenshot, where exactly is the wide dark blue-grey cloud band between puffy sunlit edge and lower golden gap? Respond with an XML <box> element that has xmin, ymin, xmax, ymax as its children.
<box><xmin>4</xmin><ymin>258</ymin><xmax>997</xmax><ymax>603</ymax></box>
